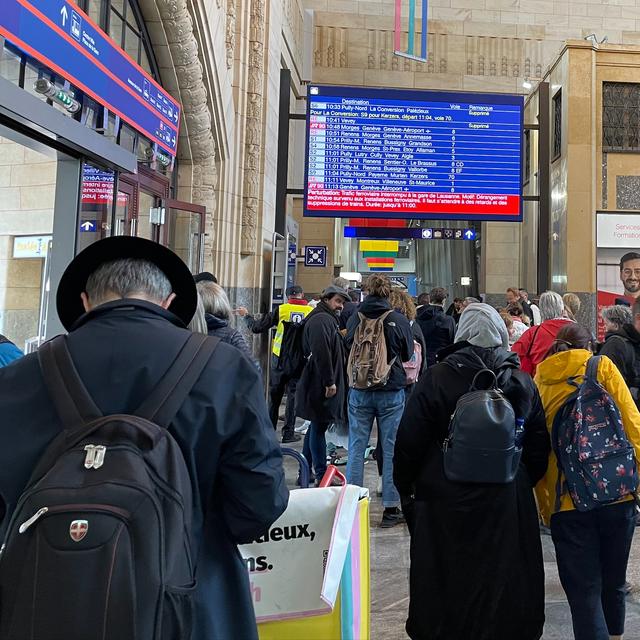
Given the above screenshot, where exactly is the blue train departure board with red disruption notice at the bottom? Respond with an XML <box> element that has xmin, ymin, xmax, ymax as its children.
<box><xmin>304</xmin><ymin>85</ymin><xmax>524</xmax><ymax>221</ymax></box>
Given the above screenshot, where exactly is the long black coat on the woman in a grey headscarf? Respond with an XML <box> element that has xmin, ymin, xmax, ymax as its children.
<box><xmin>393</xmin><ymin>343</ymin><xmax>550</xmax><ymax>640</ymax></box>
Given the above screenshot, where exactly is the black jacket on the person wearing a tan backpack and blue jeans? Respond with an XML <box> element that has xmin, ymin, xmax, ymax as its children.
<box><xmin>345</xmin><ymin>296</ymin><xmax>413</xmax><ymax>391</ymax></box>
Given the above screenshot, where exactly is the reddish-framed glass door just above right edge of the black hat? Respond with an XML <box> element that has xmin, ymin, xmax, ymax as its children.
<box><xmin>163</xmin><ymin>200</ymin><xmax>207</xmax><ymax>273</ymax></box>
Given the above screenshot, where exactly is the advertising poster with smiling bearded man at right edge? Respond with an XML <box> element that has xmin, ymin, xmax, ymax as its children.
<box><xmin>597</xmin><ymin>213</ymin><xmax>640</xmax><ymax>341</ymax></box>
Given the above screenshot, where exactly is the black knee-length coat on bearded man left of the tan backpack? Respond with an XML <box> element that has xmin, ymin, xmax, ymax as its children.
<box><xmin>296</xmin><ymin>302</ymin><xmax>347</xmax><ymax>423</ymax></box>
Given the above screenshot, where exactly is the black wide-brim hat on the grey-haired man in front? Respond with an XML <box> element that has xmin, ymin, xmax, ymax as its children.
<box><xmin>56</xmin><ymin>236</ymin><xmax>198</xmax><ymax>331</ymax></box>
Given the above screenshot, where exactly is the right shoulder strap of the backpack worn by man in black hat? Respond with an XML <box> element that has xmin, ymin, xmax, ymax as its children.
<box><xmin>133</xmin><ymin>333</ymin><xmax>220</xmax><ymax>428</ymax></box>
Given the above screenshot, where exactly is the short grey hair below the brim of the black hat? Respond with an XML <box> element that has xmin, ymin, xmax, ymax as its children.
<box><xmin>85</xmin><ymin>258</ymin><xmax>172</xmax><ymax>306</ymax></box>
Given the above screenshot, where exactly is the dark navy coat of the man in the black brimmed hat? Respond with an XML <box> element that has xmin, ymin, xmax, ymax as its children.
<box><xmin>0</xmin><ymin>300</ymin><xmax>288</xmax><ymax>640</ymax></box>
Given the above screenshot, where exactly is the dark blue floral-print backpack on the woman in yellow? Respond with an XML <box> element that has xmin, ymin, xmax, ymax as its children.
<box><xmin>551</xmin><ymin>356</ymin><xmax>638</xmax><ymax>511</ymax></box>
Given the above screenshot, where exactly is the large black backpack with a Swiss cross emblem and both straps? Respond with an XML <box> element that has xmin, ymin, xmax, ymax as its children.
<box><xmin>0</xmin><ymin>334</ymin><xmax>219</xmax><ymax>640</ymax></box>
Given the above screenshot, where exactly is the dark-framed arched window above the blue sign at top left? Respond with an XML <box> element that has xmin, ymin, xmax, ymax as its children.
<box><xmin>78</xmin><ymin>0</ymin><xmax>160</xmax><ymax>80</ymax></box>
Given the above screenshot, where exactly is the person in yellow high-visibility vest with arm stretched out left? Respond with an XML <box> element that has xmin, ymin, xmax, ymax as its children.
<box><xmin>237</xmin><ymin>285</ymin><xmax>313</xmax><ymax>444</ymax></box>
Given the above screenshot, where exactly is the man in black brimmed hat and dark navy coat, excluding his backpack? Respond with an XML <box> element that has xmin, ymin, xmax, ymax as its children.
<box><xmin>0</xmin><ymin>237</ymin><xmax>288</xmax><ymax>640</ymax></box>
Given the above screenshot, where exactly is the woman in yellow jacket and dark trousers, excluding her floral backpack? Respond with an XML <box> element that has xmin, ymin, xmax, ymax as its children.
<box><xmin>535</xmin><ymin>323</ymin><xmax>640</xmax><ymax>640</ymax></box>
